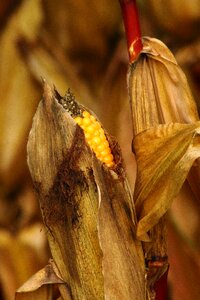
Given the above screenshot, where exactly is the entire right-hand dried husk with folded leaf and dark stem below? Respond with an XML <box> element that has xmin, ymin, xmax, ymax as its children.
<box><xmin>128</xmin><ymin>37</ymin><xmax>199</xmax><ymax>297</ymax></box>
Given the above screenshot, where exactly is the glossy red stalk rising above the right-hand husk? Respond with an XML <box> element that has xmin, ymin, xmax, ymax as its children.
<box><xmin>119</xmin><ymin>0</ymin><xmax>142</xmax><ymax>63</ymax></box>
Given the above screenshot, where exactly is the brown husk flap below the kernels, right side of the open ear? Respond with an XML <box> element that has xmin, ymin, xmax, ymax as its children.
<box><xmin>95</xmin><ymin>164</ymin><xmax>145</xmax><ymax>299</ymax></box>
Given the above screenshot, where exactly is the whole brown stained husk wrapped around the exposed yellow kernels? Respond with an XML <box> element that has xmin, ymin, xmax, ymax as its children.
<box><xmin>28</xmin><ymin>84</ymin><xmax>145</xmax><ymax>300</ymax></box>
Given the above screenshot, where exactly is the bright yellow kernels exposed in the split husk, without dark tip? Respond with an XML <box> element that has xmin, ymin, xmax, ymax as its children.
<box><xmin>74</xmin><ymin>111</ymin><xmax>114</xmax><ymax>167</ymax></box>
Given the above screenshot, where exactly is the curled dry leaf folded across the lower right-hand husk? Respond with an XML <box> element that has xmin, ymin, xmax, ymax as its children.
<box><xmin>134</xmin><ymin>122</ymin><xmax>200</xmax><ymax>238</ymax></box>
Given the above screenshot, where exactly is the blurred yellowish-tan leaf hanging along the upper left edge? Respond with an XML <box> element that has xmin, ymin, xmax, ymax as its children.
<box><xmin>0</xmin><ymin>0</ymin><xmax>43</xmax><ymax>190</ymax></box>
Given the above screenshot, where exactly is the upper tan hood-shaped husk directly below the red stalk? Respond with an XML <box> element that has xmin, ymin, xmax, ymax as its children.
<box><xmin>128</xmin><ymin>37</ymin><xmax>199</xmax><ymax>136</ymax></box>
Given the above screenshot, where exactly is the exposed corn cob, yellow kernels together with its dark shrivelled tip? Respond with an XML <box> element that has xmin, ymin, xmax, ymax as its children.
<box><xmin>59</xmin><ymin>89</ymin><xmax>114</xmax><ymax>167</ymax></box>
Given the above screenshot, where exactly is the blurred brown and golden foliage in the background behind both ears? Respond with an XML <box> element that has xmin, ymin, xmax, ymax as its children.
<box><xmin>0</xmin><ymin>0</ymin><xmax>200</xmax><ymax>300</ymax></box>
